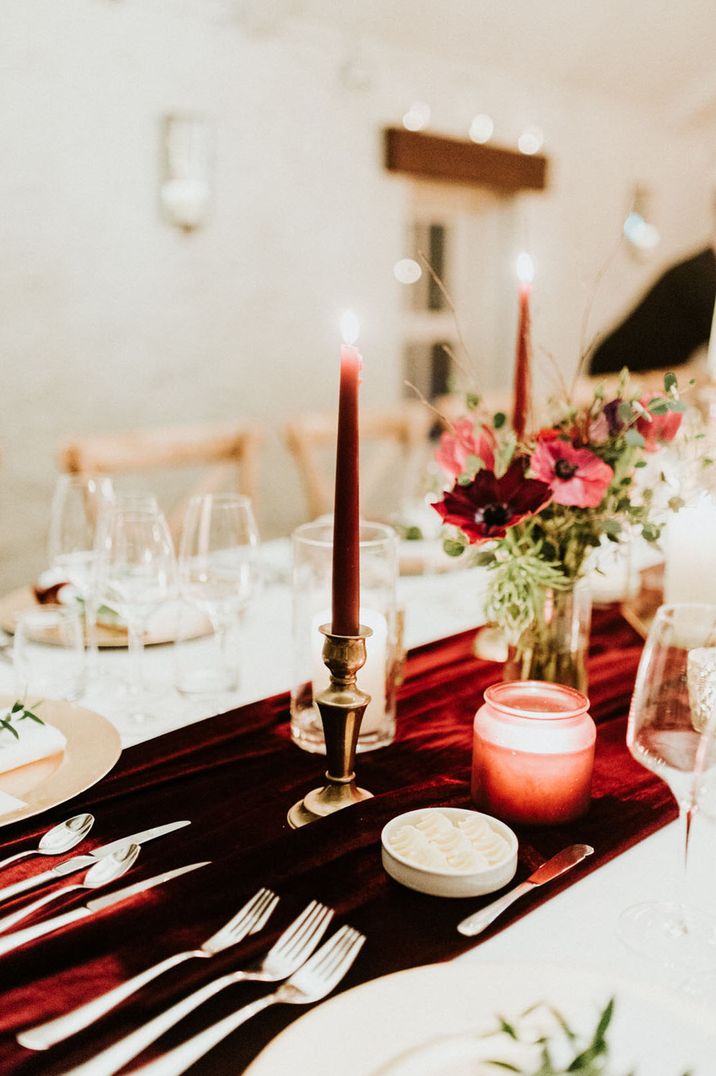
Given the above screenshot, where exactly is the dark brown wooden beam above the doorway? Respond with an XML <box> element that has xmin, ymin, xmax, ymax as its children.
<box><xmin>384</xmin><ymin>127</ymin><xmax>547</xmax><ymax>193</ymax></box>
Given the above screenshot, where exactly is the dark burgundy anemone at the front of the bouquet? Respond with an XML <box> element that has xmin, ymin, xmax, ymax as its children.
<box><xmin>433</xmin><ymin>459</ymin><xmax>552</xmax><ymax>544</ymax></box>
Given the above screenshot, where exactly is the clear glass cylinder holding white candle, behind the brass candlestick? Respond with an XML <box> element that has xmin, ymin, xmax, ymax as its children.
<box><xmin>291</xmin><ymin>518</ymin><xmax>399</xmax><ymax>752</ymax></box>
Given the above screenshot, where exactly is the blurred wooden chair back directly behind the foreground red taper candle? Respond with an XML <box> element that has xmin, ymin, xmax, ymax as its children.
<box><xmin>284</xmin><ymin>400</ymin><xmax>434</xmax><ymax>519</ymax></box>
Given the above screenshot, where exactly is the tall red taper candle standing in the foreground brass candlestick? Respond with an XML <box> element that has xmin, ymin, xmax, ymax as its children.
<box><xmin>332</xmin><ymin>344</ymin><xmax>363</xmax><ymax>635</ymax></box>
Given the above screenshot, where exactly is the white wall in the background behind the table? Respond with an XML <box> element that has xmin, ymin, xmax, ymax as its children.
<box><xmin>0</xmin><ymin>0</ymin><xmax>710</xmax><ymax>590</ymax></box>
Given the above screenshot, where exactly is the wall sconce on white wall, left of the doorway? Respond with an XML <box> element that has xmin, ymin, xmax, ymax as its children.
<box><xmin>159</xmin><ymin>114</ymin><xmax>211</xmax><ymax>231</ymax></box>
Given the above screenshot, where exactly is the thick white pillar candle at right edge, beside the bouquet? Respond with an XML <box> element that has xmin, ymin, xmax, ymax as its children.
<box><xmin>664</xmin><ymin>493</ymin><xmax>716</xmax><ymax>603</ymax></box>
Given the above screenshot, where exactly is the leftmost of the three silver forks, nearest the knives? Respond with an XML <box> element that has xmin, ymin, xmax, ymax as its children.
<box><xmin>17</xmin><ymin>889</ymin><xmax>279</xmax><ymax>1050</ymax></box>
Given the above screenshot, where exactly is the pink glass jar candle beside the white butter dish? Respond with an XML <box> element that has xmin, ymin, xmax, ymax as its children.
<box><xmin>472</xmin><ymin>680</ymin><xmax>596</xmax><ymax>825</ymax></box>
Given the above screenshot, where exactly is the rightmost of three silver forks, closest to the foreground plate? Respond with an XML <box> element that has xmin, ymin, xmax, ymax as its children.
<box><xmin>132</xmin><ymin>926</ymin><xmax>365</xmax><ymax>1076</ymax></box>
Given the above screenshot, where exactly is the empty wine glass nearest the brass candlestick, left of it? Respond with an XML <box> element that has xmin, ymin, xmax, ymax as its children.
<box><xmin>178</xmin><ymin>494</ymin><xmax>258</xmax><ymax>693</ymax></box>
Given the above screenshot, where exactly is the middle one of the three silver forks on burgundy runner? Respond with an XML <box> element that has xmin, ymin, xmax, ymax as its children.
<box><xmin>59</xmin><ymin>901</ymin><xmax>333</xmax><ymax>1076</ymax></box>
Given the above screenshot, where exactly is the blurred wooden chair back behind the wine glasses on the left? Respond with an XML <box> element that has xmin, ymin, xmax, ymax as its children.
<box><xmin>59</xmin><ymin>423</ymin><xmax>261</xmax><ymax>533</ymax></box>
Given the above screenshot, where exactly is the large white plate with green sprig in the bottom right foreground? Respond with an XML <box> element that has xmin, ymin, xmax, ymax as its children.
<box><xmin>247</xmin><ymin>964</ymin><xmax>716</xmax><ymax>1076</ymax></box>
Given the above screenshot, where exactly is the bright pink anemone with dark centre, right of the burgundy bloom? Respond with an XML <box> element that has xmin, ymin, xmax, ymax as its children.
<box><xmin>530</xmin><ymin>440</ymin><xmax>614</xmax><ymax>508</ymax></box>
